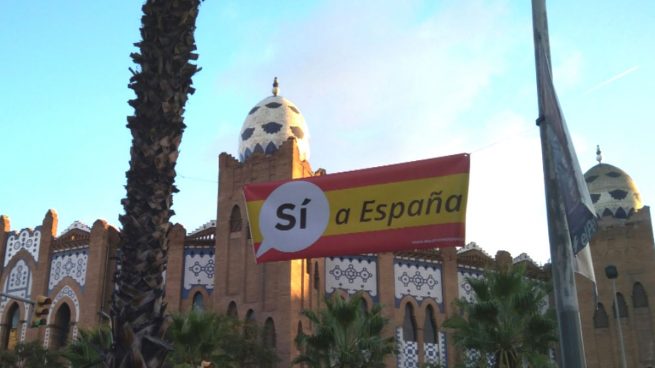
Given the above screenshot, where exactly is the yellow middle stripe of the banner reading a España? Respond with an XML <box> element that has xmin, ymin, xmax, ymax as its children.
<box><xmin>247</xmin><ymin>174</ymin><xmax>469</xmax><ymax>242</ymax></box>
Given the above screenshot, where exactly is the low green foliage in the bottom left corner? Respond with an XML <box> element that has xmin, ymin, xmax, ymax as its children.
<box><xmin>0</xmin><ymin>341</ymin><xmax>66</xmax><ymax>368</ymax></box>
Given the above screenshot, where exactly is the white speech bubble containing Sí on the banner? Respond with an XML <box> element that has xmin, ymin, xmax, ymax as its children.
<box><xmin>255</xmin><ymin>180</ymin><xmax>330</xmax><ymax>257</ymax></box>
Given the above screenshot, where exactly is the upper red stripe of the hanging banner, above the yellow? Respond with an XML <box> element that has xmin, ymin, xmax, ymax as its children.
<box><xmin>243</xmin><ymin>153</ymin><xmax>470</xmax><ymax>201</ymax></box>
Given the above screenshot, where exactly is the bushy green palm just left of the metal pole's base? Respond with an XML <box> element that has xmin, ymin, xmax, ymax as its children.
<box><xmin>444</xmin><ymin>266</ymin><xmax>557</xmax><ymax>368</ymax></box>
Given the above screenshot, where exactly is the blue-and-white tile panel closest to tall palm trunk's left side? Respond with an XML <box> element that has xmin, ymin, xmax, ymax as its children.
<box><xmin>48</xmin><ymin>246</ymin><xmax>89</xmax><ymax>291</ymax></box>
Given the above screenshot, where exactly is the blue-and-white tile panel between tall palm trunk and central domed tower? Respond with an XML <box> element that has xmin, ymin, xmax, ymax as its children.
<box><xmin>182</xmin><ymin>247</ymin><xmax>216</xmax><ymax>299</ymax></box>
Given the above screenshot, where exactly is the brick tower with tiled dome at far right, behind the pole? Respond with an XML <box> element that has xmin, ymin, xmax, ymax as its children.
<box><xmin>578</xmin><ymin>150</ymin><xmax>655</xmax><ymax>368</ymax></box>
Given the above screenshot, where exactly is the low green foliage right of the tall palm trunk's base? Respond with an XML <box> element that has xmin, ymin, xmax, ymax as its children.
<box><xmin>167</xmin><ymin>312</ymin><xmax>278</xmax><ymax>368</ymax></box>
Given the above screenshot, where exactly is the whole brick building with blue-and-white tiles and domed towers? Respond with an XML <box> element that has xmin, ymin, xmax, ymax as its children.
<box><xmin>0</xmin><ymin>87</ymin><xmax>655</xmax><ymax>367</ymax></box>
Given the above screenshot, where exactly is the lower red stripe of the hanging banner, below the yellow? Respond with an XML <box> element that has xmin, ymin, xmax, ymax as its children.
<box><xmin>255</xmin><ymin>223</ymin><xmax>465</xmax><ymax>263</ymax></box>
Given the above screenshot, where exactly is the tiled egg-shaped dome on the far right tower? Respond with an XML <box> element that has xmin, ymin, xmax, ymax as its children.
<box><xmin>584</xmin><ymin>163</ymin><xmax>644</xmax><ymax>218</ymax></box>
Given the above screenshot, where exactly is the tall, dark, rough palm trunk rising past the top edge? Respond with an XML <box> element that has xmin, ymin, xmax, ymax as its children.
<box><xmin>107</xmin><ymin>0</ymin><xmax>200</xmax><ymax>368</ymax></box>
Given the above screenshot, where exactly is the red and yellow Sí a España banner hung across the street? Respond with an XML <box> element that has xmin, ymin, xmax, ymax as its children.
<box><xmin>243</xmin><ymin>154</ymin><xmax>470</xmax><ymax>263</ymax></box>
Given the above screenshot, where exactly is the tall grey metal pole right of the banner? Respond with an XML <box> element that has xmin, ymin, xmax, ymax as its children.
<box><xmin>532</xmin><ymin>0</ymin><xmax>586</xmax><ymax>368</ymax></box>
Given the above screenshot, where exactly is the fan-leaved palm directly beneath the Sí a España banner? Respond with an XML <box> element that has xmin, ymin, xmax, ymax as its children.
<box><xmin>293</xmin><ymin>294</ymin><xmax>395</xmax><ymax>368</ymax></box>
